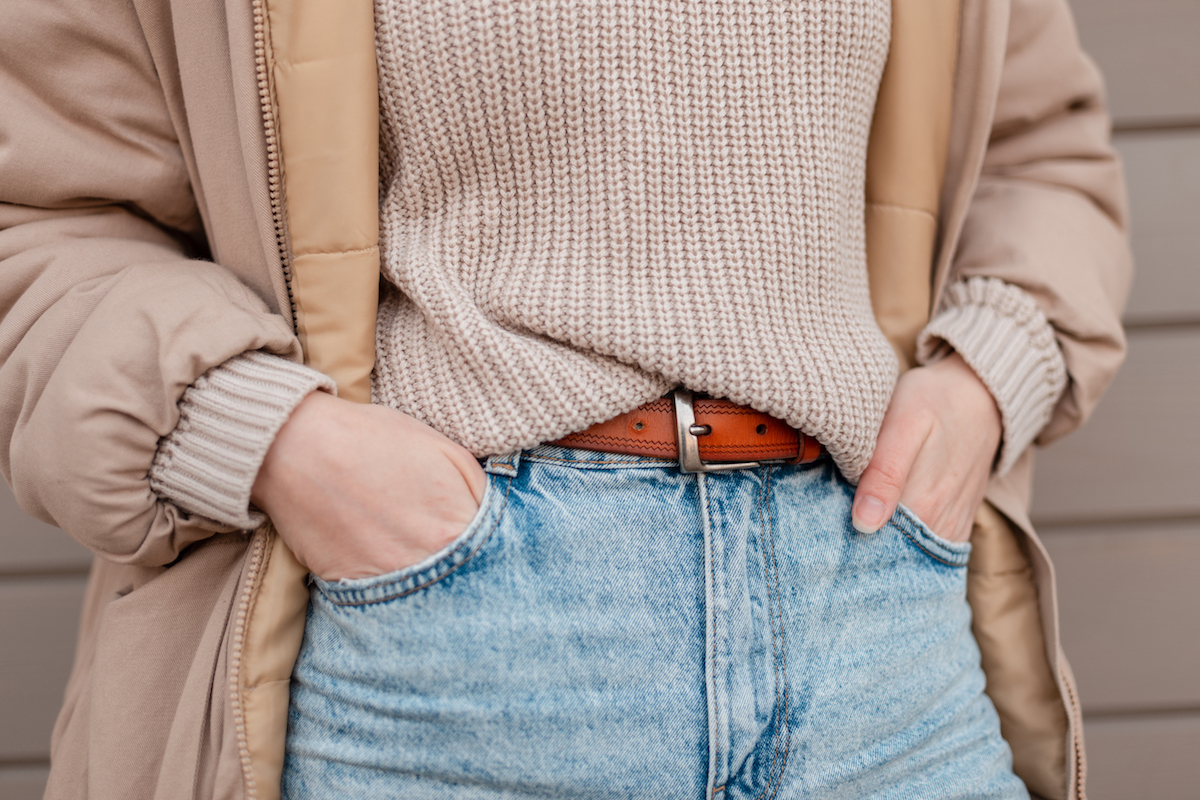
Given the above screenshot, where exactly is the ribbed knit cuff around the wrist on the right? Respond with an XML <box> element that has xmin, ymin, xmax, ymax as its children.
<box><xmin>917</xmin><ymin>278</ymin><xmax>1067</xmax><ymax>475</ymax></box>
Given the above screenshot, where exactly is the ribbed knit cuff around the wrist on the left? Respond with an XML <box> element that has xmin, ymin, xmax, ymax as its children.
<box><xmin>150</xmin><ymin>351</ymin><xmax>336</xmax><ymax>530</ymax></box>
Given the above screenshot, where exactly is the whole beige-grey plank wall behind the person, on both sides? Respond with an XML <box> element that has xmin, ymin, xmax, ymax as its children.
<box><xmin>0</xmin><ymin>0</ymin><xmax>1200</xmax><ymax>800</ymax></box>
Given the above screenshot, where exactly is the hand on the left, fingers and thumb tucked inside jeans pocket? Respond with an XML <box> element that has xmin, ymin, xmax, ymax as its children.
<box><xmin>251</xmin><ymin>391</ymin><xmax>487</xmax><ymax>581</ymax></box>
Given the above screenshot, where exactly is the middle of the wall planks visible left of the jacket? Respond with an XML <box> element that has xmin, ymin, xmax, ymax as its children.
<box><xmin>0</xmin><ymin>576</ymin><xmax>86</xmax><ymax>762</ymax></box>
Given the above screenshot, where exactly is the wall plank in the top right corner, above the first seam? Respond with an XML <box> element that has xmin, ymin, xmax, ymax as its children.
<box><xmin>1070</xmin><ymin>0</ymin><xmax>1200</xmax><ymax>122</ymax></box>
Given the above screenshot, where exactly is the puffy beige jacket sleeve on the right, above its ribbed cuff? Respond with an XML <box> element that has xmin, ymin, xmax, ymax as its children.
<box><xmin>940</xmin><ymin>0</ymin><xmax>1132</xmax><ymax>443</ymax></box>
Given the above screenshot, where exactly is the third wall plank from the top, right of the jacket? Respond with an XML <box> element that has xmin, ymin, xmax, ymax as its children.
<box><xmin>1032</xmin><ymin>326</ymin><xmax>1200</xmax><ymax>524</ymax></box>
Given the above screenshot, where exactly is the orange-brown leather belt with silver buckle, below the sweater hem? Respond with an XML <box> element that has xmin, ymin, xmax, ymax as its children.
<box><xmin>550</xmin><ymin>390</ymin><xmax>824</xmax><ymax>473</ymax></box>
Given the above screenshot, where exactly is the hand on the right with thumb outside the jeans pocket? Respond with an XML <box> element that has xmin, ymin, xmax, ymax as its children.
<box><xmin>852</xmin><ymin>353</ymin><xmax>1002</xmax><ymax>542</ymax></box>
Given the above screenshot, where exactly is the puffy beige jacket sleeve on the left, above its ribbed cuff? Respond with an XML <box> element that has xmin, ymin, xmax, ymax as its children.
<box><xmin>0</xmin><ymin>2</ymin><xmax>300</xmax><ymax>565</ymax></box>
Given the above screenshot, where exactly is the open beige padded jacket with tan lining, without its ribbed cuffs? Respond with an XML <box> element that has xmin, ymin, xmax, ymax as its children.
<box><xmin>0</xmin><ymin>0</ymin><xmax>1129</xmax><ymax>799</ymax></box>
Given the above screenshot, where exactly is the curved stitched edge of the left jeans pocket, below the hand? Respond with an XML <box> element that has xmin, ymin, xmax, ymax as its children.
<box><xmin>312</xmin><ymin>474</ymin><xmax>511</xmax><ymax>606</ymax></box>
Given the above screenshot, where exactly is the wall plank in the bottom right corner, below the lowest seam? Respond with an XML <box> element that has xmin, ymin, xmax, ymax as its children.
<box><xmin>1084</xmin><ymin>714</ymin><xmax>1200</xmax><ymax>800</ymax></box>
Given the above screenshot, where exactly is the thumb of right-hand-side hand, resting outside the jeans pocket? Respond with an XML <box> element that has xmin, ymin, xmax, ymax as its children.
<box><xmin>851</xmin><ymin>403</ymin><xmax>932</xmax><ymax>534</ymax></box>
